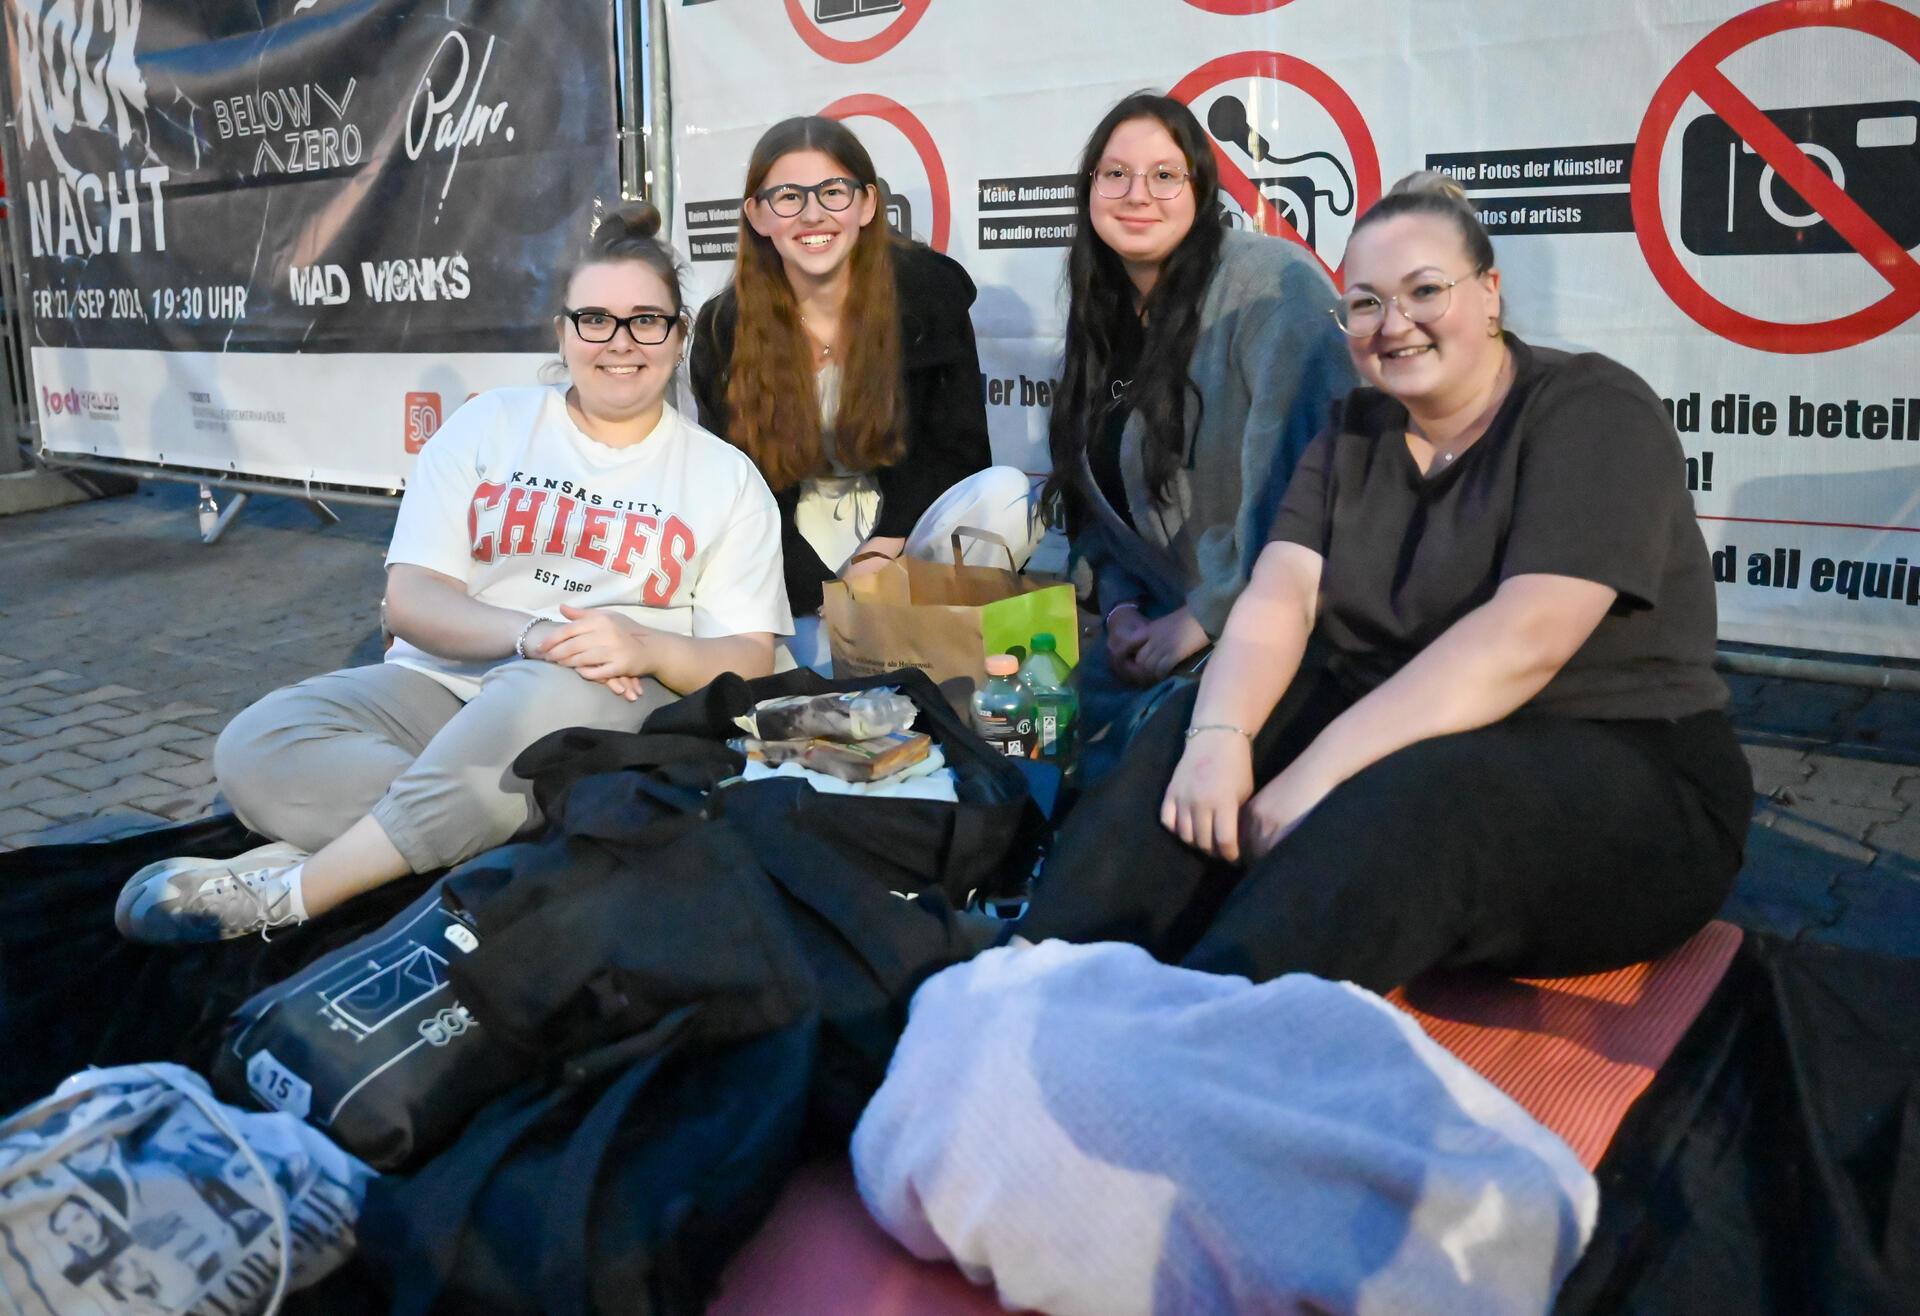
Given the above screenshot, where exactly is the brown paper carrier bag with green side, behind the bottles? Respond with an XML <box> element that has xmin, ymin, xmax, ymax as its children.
<box><xmin>826</xmin><ymin>528</ymin><xmax>1079</xmax><ymax>709</ymax></box>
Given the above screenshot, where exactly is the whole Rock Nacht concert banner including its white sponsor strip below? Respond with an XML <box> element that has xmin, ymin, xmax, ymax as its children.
<box><xmin>0</xmin><ymin>0</ymin><xmax>618</xmax><ymax>490</ymax></box>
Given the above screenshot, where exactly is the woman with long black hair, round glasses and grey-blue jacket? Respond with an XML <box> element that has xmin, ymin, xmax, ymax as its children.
<box><xmin>1048</xmin><ymin>92</ymin><xmax>1354</xmax><ymax>778</ymax></box>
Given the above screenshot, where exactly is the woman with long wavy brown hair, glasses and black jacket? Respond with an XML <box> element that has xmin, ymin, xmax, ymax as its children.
<box><xmin>691</xmin><ymin>117</ymin><xmax>1039</xmax><ymax>667</ymax></box>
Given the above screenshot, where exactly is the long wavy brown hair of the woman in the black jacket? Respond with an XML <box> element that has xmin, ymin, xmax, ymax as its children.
<box><xmin>726</xmin><ymin>115</ymin><xmax>906</xmax><ymax>490</ymax></box>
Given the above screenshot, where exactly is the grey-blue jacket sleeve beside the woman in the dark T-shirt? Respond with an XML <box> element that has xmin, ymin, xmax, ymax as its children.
<box><xmin>1187</xmin><ymin>263</ymin><xmax>1359</xmax><ymax>640</ymax></box>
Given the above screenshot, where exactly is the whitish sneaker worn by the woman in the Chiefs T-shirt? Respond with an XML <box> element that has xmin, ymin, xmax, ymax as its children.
<box><xmin>113</xmin><ymin>841</ymin><xmax>307</xmax><ymax>945</ymax></box>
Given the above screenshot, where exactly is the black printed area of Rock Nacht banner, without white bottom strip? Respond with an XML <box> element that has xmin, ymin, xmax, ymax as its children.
<box><xmin>4</xmin><ymin>0</ymin><xmax>618</xmax><ymax>353</ymax></box>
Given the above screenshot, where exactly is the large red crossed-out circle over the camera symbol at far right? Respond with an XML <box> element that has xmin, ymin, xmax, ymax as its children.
<box><xmin>1632</xmin><ymin>0</ymin><xmax>1920</xmax><ymax>352</ymax></box>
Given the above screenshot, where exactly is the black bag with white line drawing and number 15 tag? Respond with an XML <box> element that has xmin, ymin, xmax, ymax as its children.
<box><xmin>213</xmin><ymin>878</ymin><xmax>530</xmax><ymax>1170</ymax></box>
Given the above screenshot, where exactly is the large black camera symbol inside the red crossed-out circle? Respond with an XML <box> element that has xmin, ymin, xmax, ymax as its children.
<box><xmin>1680</xmin><ymin>100</ymin><xmax>1920</xmax><ymax>256</ymax></box>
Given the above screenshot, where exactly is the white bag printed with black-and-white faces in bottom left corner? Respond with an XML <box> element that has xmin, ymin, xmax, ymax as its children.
<box><xmin>0</xmin><ymin>1064</ymin><xmax>372</xmax><ymax>1316</ymax></box>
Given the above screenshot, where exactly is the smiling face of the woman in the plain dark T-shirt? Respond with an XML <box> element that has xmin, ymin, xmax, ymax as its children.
<box><xmin>1346</xmin><ymin>215</ymin><xmax>1503</xmax><ymax>411</ymax></box>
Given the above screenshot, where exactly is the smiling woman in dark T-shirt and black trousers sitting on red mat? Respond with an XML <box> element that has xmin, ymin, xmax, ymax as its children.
<box><xmin>1021</xmin><ymin>173</ymin><xmax>1753</xmax><ymax>989</ymax></box>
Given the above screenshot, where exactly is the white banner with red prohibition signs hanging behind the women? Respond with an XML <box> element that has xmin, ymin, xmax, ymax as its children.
<box><xmin>666</xmin><ymin>0</ymin><xmax>1920</xmax><ymax>657</ymax></box>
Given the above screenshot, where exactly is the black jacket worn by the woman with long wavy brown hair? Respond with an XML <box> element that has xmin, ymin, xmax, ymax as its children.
<box><xmin>687</xmin><ymin>242</ymin><xmax>993</xmax><ymax>617</ymax></box>
